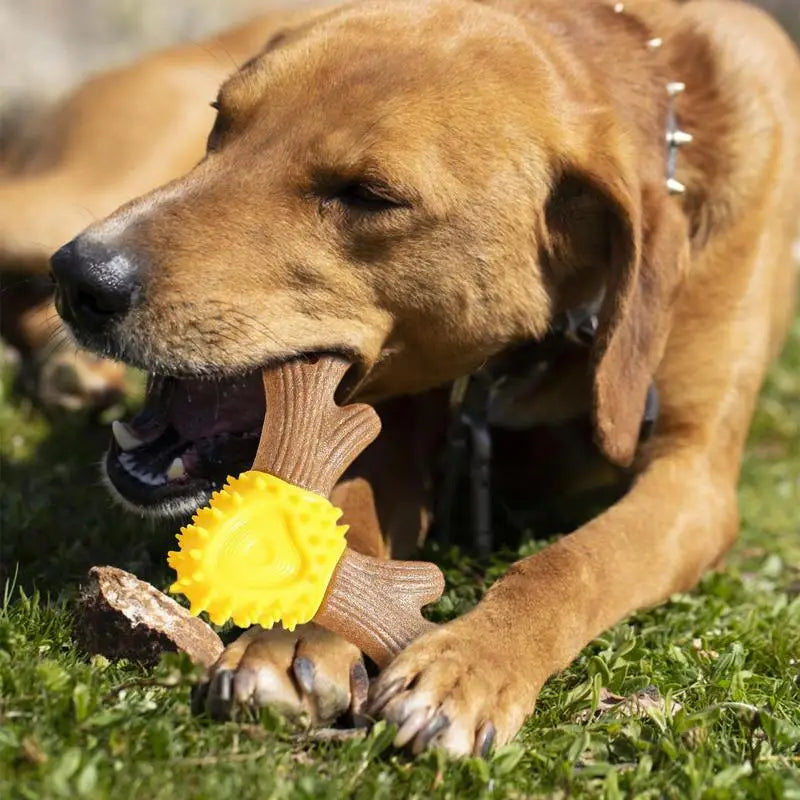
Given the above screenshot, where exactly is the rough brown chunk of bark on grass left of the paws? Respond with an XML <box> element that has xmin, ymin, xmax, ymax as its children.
<box><xmin>75</xmin><ymin>567</ymin><xmax>223</xmax><ymax>667</ymax></box>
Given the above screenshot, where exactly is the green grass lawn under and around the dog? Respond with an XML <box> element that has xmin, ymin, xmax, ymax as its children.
<box><xmin>0</xmin><ymin>320</ymin><xmax>800</xmax><ymax>800</ymax></box>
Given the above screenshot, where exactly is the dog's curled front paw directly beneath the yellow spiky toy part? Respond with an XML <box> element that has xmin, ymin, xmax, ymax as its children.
<box><xmin>192</xmin><ymin>623</ymin><xmax>369</xmax><ymax>725</ymax></box>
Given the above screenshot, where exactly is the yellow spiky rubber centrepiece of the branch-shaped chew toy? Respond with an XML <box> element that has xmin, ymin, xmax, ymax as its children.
<box><xmin>168</xmin><ymin>470</ymin><xmax>347</xmax><ymax>631</ymax></box>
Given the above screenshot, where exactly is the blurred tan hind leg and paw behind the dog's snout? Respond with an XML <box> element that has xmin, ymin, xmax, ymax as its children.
<box><xmin>0</xmin><ymin>0</ymin><xmax>318</xmax><ymax>409</ymax></box>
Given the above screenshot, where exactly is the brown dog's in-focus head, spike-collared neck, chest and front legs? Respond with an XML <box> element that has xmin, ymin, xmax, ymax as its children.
<box><xmin>52</xmin><ymin>0</ymin><xmax>800</xmax><ymax>754</ymax></box>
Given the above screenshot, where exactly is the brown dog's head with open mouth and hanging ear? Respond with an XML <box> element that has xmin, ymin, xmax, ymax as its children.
<box><xmin>53</xmin><ymin>0</ymin><xmax>686</xmax><ymax>511</ymax></box>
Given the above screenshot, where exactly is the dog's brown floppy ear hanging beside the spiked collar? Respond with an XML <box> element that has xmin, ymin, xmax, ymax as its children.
<box><xmin>551</xmin><ymin>154</ymin><xmax>689</xmax><ymax>466</ymax></box>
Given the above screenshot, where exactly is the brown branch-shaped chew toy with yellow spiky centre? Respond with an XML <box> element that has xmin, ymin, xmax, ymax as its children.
<box><xmin>169</xmin><ymin>356</ymin><xmax>444</xmax><ymax>667</ymax></box>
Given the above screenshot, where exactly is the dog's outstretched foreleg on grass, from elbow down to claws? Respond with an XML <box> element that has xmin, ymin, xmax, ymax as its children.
<box><xmin>370</xmin><ymin>438</ymin><xmax>736</xmax><ymax>755</ymax></box>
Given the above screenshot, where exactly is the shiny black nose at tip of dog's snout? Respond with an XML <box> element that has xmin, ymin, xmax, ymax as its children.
<box><xmin>50</xmin><ymin>237</ymin><xmax>140</xmax><ymax>332</ymax></box>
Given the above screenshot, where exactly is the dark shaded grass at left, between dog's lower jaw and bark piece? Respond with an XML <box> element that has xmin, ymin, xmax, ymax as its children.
<box><xmin>0</xmin><ymin>394</ymin><xmax>176</xmax><ymax>596</ymax></box>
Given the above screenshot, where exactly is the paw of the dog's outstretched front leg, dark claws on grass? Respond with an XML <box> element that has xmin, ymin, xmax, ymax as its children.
<box><xmin>368</xmin><ymin>618</ymin><xmax>537</xmax><ymax>756</ymax></box>
